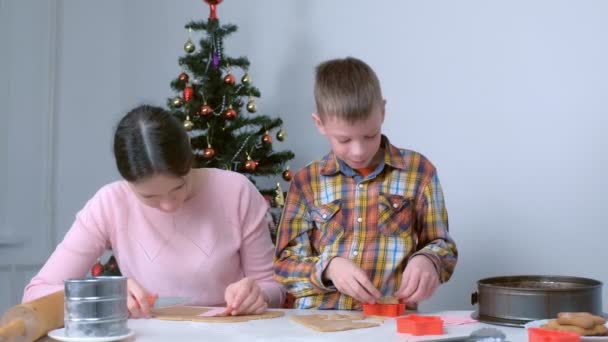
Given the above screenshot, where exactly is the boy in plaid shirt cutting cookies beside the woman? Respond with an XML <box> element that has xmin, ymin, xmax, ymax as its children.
<box><xmin>274</xmin><ymin>58</ymin><xmax>457</xmax><ymax>310</ymax></box>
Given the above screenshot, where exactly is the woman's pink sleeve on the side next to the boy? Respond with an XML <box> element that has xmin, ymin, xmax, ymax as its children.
<box><xmin>239</xmin><ymin>181</ymin><xmax>285</xmax><ymax>307</ymax></box>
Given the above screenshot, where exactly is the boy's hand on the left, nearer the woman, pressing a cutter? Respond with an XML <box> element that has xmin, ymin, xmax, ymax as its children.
<box><xmin>324</xmin><ymin>257</ymin><xmax>382</xmax><ymax>304</ymax></box>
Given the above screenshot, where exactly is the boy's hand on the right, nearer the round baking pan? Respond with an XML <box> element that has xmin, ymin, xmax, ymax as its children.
<box><xmin>395</xmin><ymin>255</ymin><xmax>439</xmax><ymax>304</ymax></box>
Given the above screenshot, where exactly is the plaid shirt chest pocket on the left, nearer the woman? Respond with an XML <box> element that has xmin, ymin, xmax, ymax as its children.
<box><xmin>310</xmin><ymin>200</ymin><xmax>344</xmax><ymax>250</ymax></box>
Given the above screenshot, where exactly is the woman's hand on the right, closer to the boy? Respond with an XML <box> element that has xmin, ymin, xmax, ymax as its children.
<box><xmin>224</xmin><ymin>278</ymin><xmax>268</xmax><ymax>316</ymax></box>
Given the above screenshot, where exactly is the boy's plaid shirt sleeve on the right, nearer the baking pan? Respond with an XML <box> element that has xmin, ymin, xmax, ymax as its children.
<box><xmin>410</xmin><ymin>172</ymin><xmax>458</xmax><ymax>283</ymax></box>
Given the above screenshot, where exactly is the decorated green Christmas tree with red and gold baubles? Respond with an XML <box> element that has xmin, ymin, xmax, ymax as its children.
<box><xmin>167</xmin><ymin>0</ymin><xmax>294</xmax><ymax>202</ymax></box>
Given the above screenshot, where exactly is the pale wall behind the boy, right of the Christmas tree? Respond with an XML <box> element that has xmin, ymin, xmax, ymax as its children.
<box><xmin>173</xmin><ymin>0</ymin><xmax>608</xmax><ymax>310</ymax></box>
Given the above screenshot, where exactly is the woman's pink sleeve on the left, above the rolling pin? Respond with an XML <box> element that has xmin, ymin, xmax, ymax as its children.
<box><xmin>22</xmin><ymin>195</ymin><xmax>109</xmax><ymax>302</ymax></box>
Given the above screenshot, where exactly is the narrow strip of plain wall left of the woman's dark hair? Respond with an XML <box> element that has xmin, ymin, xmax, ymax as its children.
<box><xmin>54</xmin><ymin>0</ymin><xmax>129</xmax><ymax>243</ymax></box>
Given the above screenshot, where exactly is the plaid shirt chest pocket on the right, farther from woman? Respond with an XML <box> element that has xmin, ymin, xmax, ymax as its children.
<box><xmin>378</xmin><ymin>193</ymin><xmax>415</xmax><ymax>236</ymax></box>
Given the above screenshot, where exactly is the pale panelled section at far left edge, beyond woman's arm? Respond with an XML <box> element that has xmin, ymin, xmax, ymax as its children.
<box><xmin>0</xmin><ymin>0</ymin><xmax>56</xmax><ymax>309</ymax></box>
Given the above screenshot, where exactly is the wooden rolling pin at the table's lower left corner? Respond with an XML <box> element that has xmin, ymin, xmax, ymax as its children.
<box><xmin>0</xmin><ymin>291</ymin><xmax>64</xmax><ymax>342</ymax></box>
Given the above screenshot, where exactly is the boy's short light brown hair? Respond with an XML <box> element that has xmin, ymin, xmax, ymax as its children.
<box><xmin>315</xmin><ymin>57</ymin><xmax>382</xmax><ymax>123</ymax></box>
